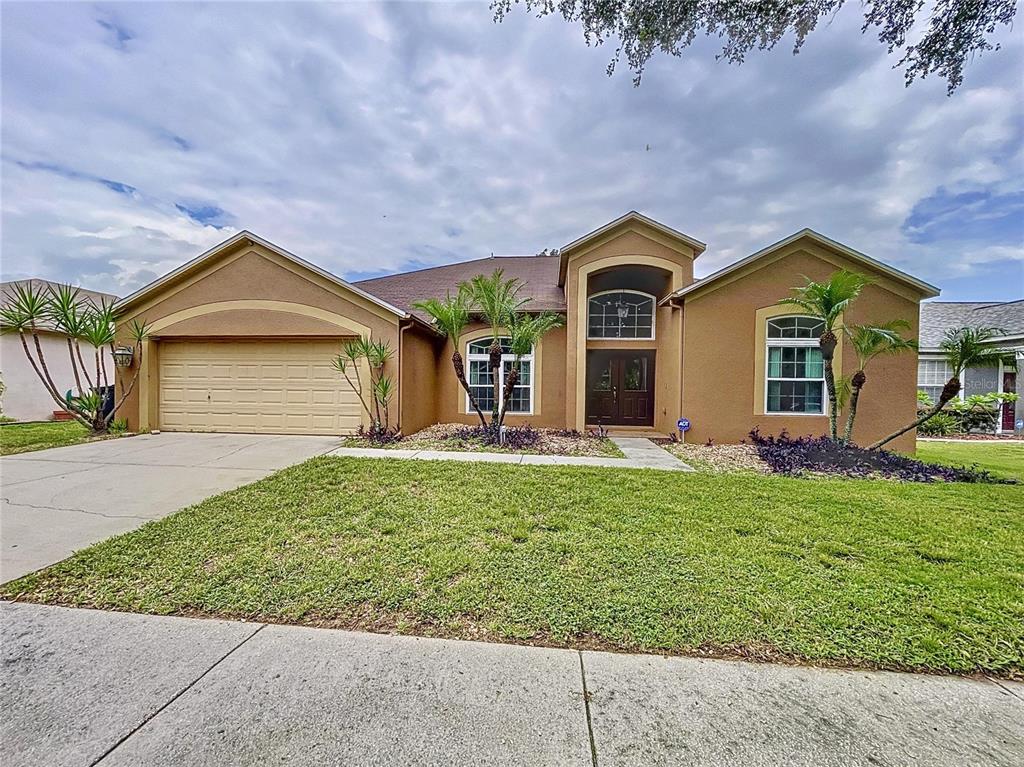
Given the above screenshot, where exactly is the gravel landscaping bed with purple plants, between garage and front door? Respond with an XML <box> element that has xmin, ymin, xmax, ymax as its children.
<box><xmin>342</xmin><ymin>424</ymin><xmax>623</xmax><ymax>458</ymax></box>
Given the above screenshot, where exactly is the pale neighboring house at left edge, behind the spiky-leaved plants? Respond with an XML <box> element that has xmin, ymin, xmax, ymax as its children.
<box><xmin>0</xmin><ymin>280</ymin><xmax>117</xmax><ymax>421</ymax></box>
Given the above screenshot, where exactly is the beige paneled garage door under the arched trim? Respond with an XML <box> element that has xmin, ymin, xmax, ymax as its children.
<box><xmin>160</xmin><ymin>340</ymin><xmax>361</xmax><ymax>434</ymax></box>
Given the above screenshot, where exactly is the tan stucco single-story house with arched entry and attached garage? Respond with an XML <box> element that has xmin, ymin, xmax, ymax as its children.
<box><xmin>110</xmin><ymin>212</ymin><xmax>938</xmax><ymax>450</ymax></box>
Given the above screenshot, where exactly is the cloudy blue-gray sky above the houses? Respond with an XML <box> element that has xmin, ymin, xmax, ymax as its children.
<box><xmin>0</xmin><ymin>2</ymin><xmax>1024</xmax><ymax>300</ymax></box>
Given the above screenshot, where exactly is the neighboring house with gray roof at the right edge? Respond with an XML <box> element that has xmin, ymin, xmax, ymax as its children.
<box><xmin>918</xmin><ymin>299</ymin><xmax>1024</xmax><ymax>433</ymax></box>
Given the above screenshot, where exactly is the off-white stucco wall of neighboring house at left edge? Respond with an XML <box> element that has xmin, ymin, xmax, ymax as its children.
<box><xmin>0</xmin><ymin>333</ymin><xmax>114</xmax><ymax>421</ymax></box>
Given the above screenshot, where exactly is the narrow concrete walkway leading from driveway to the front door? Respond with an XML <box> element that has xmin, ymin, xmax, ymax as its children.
<box><xmin>328</xmin><ymin>437</ymin><xmax>693</xmax><ymax>471</ymax></box>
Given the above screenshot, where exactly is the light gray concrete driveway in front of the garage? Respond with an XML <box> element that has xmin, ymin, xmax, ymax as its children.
<box><xmin>0</xmin><ymin>433</ymin><xmax>338</xmax><ymax>583</ymax></box>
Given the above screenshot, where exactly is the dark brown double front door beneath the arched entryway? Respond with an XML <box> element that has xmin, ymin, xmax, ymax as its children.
<box><xmin>587</xmin><ymin>349</ymin><xmax>654</xmax><ymax>426</ymax></box>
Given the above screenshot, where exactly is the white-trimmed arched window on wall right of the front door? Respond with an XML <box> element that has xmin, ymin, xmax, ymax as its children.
<box><xmin>765</xmin><ymin>316</ymin><xmax>825</xmax><ymax>415</ymax></box>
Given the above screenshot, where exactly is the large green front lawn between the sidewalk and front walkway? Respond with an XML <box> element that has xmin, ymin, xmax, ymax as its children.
<box><xmin>0</xmin><ymin>458</ymin><xmax>1024</xmax><ymax>677</ymax></box>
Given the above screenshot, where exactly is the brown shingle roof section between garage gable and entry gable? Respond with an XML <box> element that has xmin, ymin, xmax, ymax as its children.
<box><xmin>353</xmin><ymin>255</ymin><xmax>565</xmax><ymax>322</ymax></box>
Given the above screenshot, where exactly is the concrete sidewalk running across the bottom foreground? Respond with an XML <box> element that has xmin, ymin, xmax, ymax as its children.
<box><xmin>0</xmin><ymin>603</ymin><xmax>1024</xmax><ymax>767</ymax></box>
